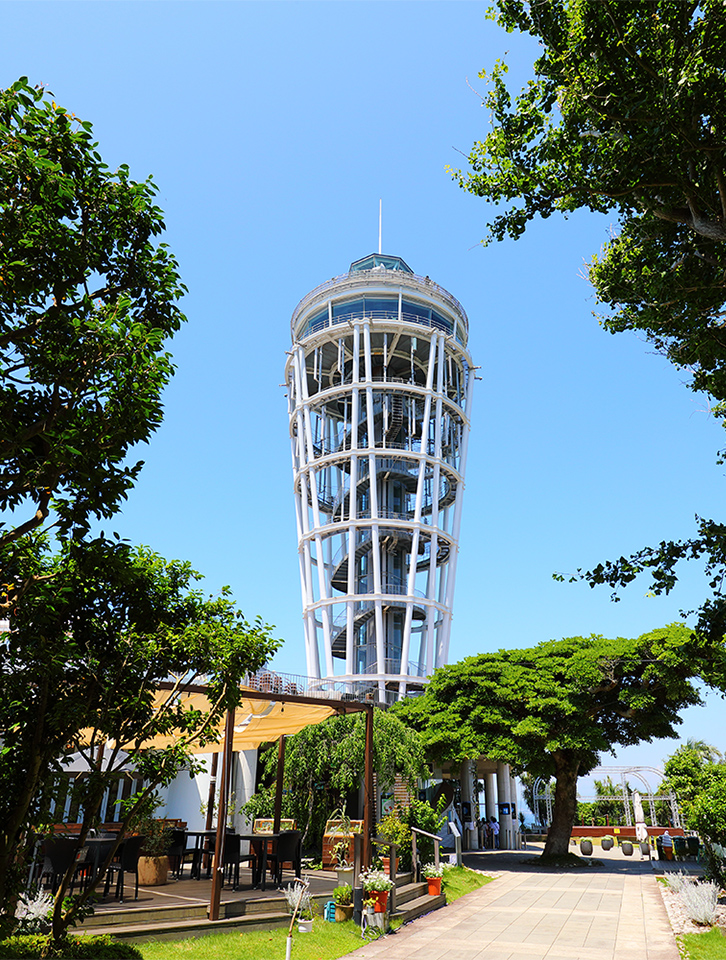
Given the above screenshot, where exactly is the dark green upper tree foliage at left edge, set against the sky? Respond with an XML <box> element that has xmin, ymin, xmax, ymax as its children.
<box><xmin>0</xmin><ymin>77</ymin><xmax>185</xmax><ymax>564</ymax></box>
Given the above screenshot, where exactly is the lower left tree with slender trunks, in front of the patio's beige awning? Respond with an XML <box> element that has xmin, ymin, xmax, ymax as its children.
<box><xmin>0</xmin><ymin>536</ymin><xmax>278</xmax><ymax>941</ymax></box>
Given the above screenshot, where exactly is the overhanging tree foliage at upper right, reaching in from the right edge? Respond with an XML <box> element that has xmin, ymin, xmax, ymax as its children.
<box><xmin>454</xmin><ymin>0</ymin><xmax>726</xmax><ymax>642</ymax></box>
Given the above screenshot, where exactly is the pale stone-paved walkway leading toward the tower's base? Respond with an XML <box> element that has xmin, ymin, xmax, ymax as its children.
<box><xmin>348</xmin><ymin>850</ymin><xmax>679</xmax><ymax>960</ymax></box>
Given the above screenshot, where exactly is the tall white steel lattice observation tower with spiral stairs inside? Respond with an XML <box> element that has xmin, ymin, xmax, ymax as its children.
<box><xmin>286</xmin><ymin>254</ymin><xmax>474</xmax><ymax>702</ymax></box>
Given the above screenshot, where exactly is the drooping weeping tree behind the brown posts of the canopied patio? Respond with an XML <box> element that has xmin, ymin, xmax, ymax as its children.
<box><xmin>242</xmin><ymin>710</ymin><xmax>428</xmax><ymax>848</ymax></box>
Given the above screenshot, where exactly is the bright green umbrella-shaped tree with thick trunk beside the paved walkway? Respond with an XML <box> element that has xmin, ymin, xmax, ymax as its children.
<box><xmin>396</xmin><ymin>624</ymin><xmax>700</xmax><ymax>856</ymax></box>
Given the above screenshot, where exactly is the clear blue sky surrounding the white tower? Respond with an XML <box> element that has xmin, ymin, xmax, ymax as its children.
<box><xmin>7</xmin><ymin>0</ymin><xmax>726</xmax><ymax>780</ymax></box>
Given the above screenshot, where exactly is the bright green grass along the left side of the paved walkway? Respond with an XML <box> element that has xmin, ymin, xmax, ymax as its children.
<box><xmin>138</xmin><ymin>867</ymin><xmax>498</xmax><ymax>960</ymax></box>
